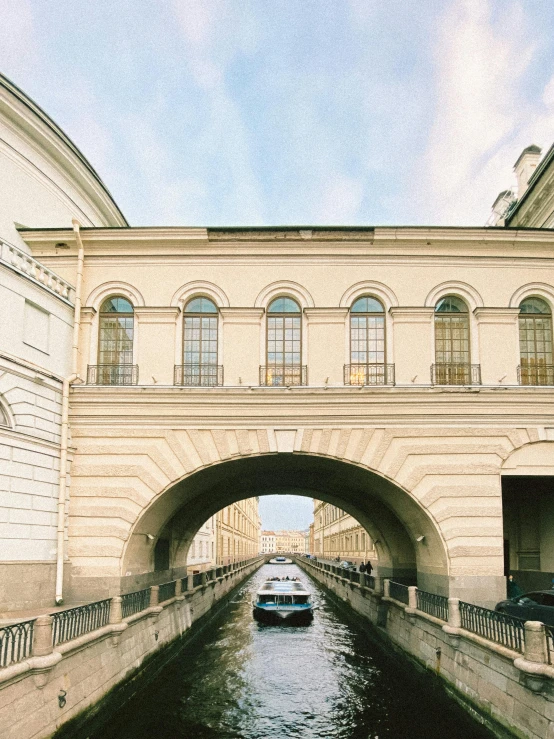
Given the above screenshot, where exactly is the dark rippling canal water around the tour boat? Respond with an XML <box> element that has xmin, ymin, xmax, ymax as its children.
<box><xmin>84</xmin><ymin>565</ymin><xmax>492</xmax><ymax>739</ymax></box>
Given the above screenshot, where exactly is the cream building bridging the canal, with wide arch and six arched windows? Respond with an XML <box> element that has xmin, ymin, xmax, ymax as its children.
<box><xmin>12</xmin><ymin>223</ymin><xmax>554</xmax><ymax>604</ymax></box>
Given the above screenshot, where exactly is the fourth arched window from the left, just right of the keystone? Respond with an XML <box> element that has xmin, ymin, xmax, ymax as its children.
<box><xmin>345</xmin><ymin>295</ymin><xmax>391</xmax><ymax>385</ymax></box>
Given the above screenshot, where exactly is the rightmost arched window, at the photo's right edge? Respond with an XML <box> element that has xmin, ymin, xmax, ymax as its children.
<box><xmin>519</xmin><ymin>298</ymin><xmax>554</xmax><ymax>385</ymax></box>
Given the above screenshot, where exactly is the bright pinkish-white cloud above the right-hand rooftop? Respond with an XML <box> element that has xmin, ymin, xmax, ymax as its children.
<box><xmin>417</xmin><ymin>0</ymin><xmax>554</xmax><ymax>224</ymax></box>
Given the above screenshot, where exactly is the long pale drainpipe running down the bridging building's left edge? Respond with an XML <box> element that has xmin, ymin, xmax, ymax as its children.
<box><xmin>56</xmin><ymin>220</ymin><xmax>85</xmax><ymax>606</ymax></box>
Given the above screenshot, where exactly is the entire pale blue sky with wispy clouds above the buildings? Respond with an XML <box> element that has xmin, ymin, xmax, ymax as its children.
<box><xmin>0</xmin><ymin>0</ymin><xmax>554</xmax><ymax>226</ymax></box>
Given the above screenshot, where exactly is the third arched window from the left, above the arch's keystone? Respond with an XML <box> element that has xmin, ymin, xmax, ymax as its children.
<box><xmin>260</xmin><ymin>298</ymin><xmax>306</xmax><ymax>386</ymax></box>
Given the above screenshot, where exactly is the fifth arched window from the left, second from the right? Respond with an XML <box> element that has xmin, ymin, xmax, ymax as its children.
<box><xmin>433</xmin><ymin>295</ymin><xmax>472</xmax><ymax>385</ymax></box>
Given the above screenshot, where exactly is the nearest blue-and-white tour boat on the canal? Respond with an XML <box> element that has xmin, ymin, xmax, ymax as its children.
<box><xmin>252</xmin><ymin>580</ymin><xmax>313</xmax><ymax>623</ymax></box>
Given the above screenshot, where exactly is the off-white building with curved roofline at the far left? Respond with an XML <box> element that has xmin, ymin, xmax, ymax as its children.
<box><xmin>0</xmin><ymin>74</ymin><xmax>127</xmax><ymax>613</ymax></box>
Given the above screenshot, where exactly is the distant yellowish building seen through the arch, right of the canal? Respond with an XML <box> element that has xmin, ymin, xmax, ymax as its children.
<box><xmin>310</xmin><ymin>499</ymin><xmax>377</xmax><ymax>565</ymax></box>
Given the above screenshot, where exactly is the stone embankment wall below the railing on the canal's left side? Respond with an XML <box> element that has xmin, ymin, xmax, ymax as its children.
<box><xmin>0</xmin><ymin>558</ymin><xmax>264</xmax><ymax>739</ymax></box>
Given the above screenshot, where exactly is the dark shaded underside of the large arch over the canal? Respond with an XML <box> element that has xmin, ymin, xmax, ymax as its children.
<box><xmin>121</xmin><ymin>453</ymin><xmax>448</xmax><ymax>594</ymax></box>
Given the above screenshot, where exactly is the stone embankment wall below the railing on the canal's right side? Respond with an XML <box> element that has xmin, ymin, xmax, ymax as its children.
<box><xmin>297</xmin><ymin>558</ymin><xmax>554</xmax><ymax>739</ymax></box>
